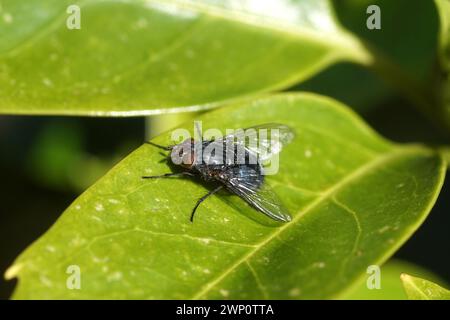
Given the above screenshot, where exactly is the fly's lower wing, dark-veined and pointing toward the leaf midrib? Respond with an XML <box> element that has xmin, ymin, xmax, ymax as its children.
<box><xmin>222</xmin><ymin>166</ymin><xmax>291</xmax><ymax>222</ymax></box>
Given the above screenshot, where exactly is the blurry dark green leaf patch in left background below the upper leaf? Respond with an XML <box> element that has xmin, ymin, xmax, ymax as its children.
<box><xmin>26</xmin><ymin>119</ymin><xmax>135</xmax><ymax>192</ymax></box>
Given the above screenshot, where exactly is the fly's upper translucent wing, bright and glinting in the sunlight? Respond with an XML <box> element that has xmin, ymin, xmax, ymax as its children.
<box><xmin>220</xmin><ymin>123</ymin><xmax>295</xmax><ymax>161</ymax></box>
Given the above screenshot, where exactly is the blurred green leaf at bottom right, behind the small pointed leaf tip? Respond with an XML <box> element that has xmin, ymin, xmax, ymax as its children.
<box><xmin>344</xmin><ymin>260</ymin><xmax>442</xmax><ymax>300</ymax></box>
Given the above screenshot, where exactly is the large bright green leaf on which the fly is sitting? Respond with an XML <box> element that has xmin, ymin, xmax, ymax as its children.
<box><xmin>6</xmin><ymin>94</ymin><xmax>446</xmax><ymax>299</ymax></box>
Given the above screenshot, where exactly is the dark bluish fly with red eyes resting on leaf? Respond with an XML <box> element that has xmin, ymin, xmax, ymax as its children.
<box><xmin>142</xmin><ymin>123</ymin><xmax>294</xmax><ymax>222</ymax></box>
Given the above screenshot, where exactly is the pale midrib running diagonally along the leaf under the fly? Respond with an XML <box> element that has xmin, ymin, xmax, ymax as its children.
<box><xmin>191</xmin><ymin>145</ymin><xmax>432</xmax><ymax>300</ymax></box>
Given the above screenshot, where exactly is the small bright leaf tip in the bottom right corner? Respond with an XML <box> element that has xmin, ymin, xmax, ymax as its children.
<box><xmin>401</xmin><ymin>274</ymin><xmax>450</xmax><ymax>300</ymax></box>
